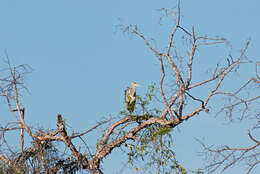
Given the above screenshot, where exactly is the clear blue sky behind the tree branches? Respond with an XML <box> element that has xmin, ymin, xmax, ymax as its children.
<box><xmin>0</xmin><ymin>0</ymin><xmax>260</xmax><ymax>174</ymax></box>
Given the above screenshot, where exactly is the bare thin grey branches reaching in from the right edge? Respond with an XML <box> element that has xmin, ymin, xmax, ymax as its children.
<box><xmin>201</xmin><ymin>62</ymin><xmax>260</xmax><ymax>174</ymax></box>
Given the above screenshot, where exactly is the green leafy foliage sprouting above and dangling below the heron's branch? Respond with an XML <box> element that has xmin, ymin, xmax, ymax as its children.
<box><xmin>120</xmin><ymin>83</ymin><xmax>193</xmax><ymax>174</ymax></box>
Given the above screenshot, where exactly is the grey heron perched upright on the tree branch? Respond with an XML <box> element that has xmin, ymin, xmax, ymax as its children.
<box><xmin>125</xmin><ymin>82</ymin><xmax>140</xmax><ymax>113</ymax></box>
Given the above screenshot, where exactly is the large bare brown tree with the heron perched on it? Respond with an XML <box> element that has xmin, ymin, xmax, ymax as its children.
<box><xmin>0</xmin><ymin>1</ymin><xmax>259</xmax><ymax>174</ymax></box>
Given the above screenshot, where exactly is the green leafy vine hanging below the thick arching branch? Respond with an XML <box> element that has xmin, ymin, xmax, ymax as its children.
<box><xmin>125</xmin><ymin>121</ymin><xmax>187</xmax><ymax>174</ymax></box>
